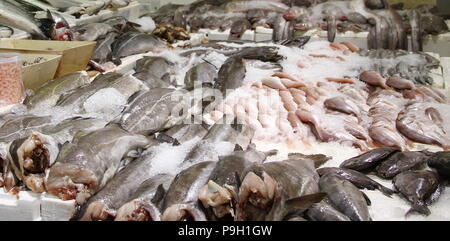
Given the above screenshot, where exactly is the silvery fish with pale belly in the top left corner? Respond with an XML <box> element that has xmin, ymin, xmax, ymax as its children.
<box><xmin>0</xmin><ymin>1</ymin><xmax>48</xmax><ymax>39</ymax></box>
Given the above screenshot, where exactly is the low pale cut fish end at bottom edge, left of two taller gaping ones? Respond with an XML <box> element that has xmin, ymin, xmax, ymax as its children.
<box><xmin>161</xmin><ymin>203</ymin><xmax>206</xmax><ymax>221</ymax></box>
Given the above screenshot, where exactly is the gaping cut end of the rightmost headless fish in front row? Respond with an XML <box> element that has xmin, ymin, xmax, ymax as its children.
<box><xmin>235</xmin><ymin>172</ymin><xmax>277</xmax><ymax>220</ymax></box>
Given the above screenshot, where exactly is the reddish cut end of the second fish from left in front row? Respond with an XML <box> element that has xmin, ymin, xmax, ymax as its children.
<box><xmin>45</xmin><ymin>163</ymin><xmax>97</xmax><ymax>204</ymax></box>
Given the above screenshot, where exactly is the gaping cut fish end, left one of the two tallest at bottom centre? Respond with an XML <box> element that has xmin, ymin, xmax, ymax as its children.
<box><xmin>198</xmin><ymin>180</ymin><xmax>237</xmax><ymax>218</ymax></box>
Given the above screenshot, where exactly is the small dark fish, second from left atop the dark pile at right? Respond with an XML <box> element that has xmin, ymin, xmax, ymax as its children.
<box><xmin>376</xmin><ymin>151</ymin><xmax>430</xmax><ymax>178</ymax></box>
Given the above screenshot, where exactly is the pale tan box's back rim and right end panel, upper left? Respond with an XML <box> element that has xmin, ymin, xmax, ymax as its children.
<box><xmin>0</xmin><ymin>39</ymin><xmax>95</xmax><ymax>78</ymax></box>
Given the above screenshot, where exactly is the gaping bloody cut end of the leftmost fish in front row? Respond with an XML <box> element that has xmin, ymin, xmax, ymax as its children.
<box><xmin>8</xmin><ymin>132</ymin><xmax>59</xmax><ymax>193</ymax></box>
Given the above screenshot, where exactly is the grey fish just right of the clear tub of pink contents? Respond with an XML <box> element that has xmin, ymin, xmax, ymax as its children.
<box><xmin>24</xmin><ymin>72</ymin><xmax>90</xmax><ymax>109</ymax></box>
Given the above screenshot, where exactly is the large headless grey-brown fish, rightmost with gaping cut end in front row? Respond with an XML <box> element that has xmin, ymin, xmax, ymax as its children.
<box><xmin>235</xmin><ymin>154</ymin><xmax>329</xmax><ymax>221</ymax></box>
